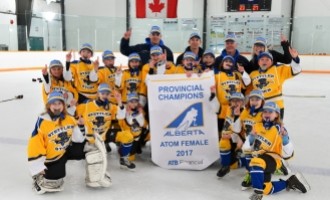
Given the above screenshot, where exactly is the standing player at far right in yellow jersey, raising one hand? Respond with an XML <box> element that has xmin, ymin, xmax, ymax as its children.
<box><xmin>250</xmin><ymin>48</ymin><xmax>301</xmax><ymax>119</ymax></box>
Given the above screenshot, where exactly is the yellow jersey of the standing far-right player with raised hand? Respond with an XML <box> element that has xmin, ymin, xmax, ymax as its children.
<box><xmin>250</xmin><ymin>65</ymin><xmax>294</xmax><ymax>108</ymax></box>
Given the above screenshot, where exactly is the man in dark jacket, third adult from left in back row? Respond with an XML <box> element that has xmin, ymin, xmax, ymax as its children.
<box><xmin>215</xmin><ymin>34</ymin><xmax>251</xmax><ymax>73</ymax></box>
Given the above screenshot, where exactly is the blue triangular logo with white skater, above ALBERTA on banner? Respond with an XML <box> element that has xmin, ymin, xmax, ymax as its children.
<box><xmin>166</xmin><ymin>102</ymin><xmax>204</xmax><ymax>131</ymax></box>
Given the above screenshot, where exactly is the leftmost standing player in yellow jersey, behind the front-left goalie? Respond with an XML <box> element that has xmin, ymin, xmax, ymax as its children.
<box><xmin>42</xmin><ymin>60</ymin><xmax>78</xmax><ymax>116</ymax></box>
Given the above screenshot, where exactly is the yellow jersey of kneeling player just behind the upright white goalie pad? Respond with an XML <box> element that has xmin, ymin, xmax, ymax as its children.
<box><xmin>83</xmin><ymin>100</ymin><xmax>125</xmax><ymax>144</ymax></box>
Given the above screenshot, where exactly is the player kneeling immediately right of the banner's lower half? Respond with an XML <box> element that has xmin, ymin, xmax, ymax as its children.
<box><xmin>217</xmin><ymin>92</ymin><xmax>245</xmax><ymax>178</ymax></box>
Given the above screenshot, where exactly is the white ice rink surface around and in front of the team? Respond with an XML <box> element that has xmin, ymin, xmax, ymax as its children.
<box><xmin>0</xmin><ymin>71</ymin><xmax>330</xmax><ymax>200</ymax></box>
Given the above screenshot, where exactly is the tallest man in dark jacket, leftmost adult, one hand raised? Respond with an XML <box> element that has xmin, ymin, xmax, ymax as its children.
<box><xmin>120</xmin><ymin>26</ymin><xmax>174</xmax><ymax>66</ymax></box>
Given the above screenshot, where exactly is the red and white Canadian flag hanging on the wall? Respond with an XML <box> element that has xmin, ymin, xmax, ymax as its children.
<box><xmin>135</xmin><ymin>0</ymin><xmax>178</xmax><ymax>18</ymax></box>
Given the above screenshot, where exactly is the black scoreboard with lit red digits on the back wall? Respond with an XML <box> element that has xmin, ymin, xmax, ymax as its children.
<box><xmin>226</xmin><ymin>0</ymin><xmax>272</xmax><ymax>12</ymax></box>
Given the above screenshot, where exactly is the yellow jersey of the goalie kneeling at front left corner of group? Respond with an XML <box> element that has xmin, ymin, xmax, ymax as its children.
<box><xmin>27</xmin><ymin>113</ymin><xmax>84</xmax><ymax>175</ymax></box>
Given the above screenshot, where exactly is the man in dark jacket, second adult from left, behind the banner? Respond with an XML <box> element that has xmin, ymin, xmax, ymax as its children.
<box><xmin>175</xmin><ymin>33</ymin><xmax>204</xmax><ymax>65</ymax></box>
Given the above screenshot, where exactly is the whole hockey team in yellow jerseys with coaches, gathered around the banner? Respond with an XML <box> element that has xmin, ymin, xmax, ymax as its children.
<box><xmin>27</xmin><ymin>26</ymin><xmax>309</xmax><ymax>200</ymax></box>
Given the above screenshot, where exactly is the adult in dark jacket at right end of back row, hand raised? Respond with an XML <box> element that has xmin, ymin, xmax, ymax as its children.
<box><xmin>246</xmin><ymin>35</ymin><xmax>292</xmax><ymax>74</ymax></box>
